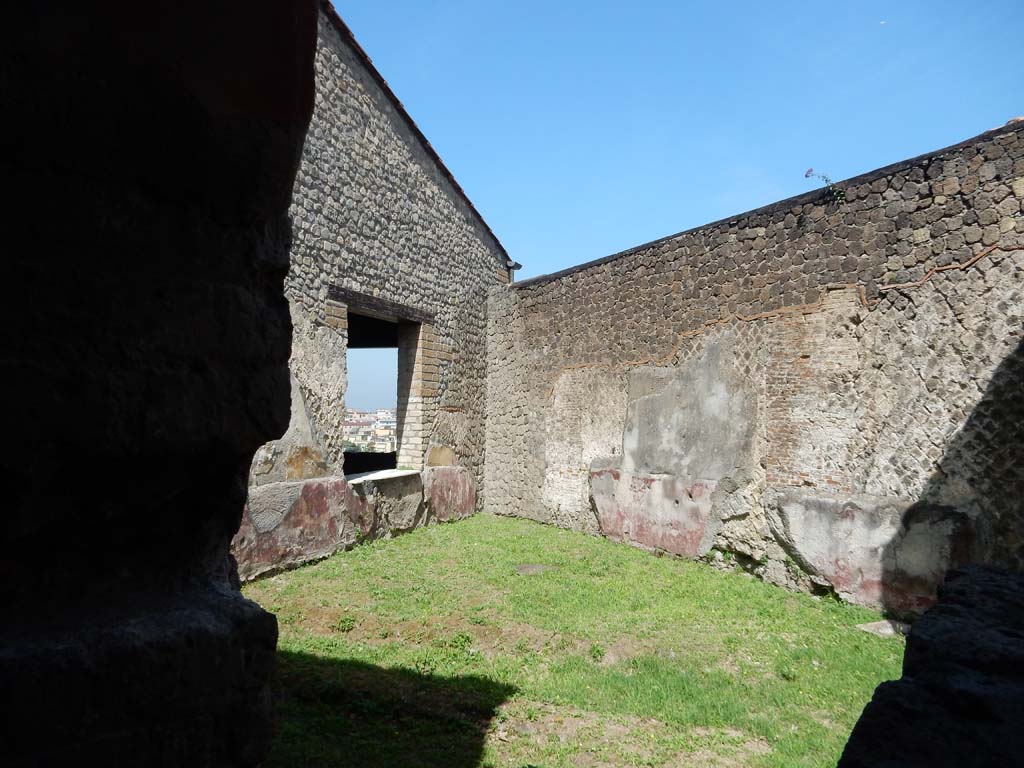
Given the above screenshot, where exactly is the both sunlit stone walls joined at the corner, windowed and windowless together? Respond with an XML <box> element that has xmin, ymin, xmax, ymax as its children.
<box><xmin>228</xmin><ymin>3</ymin><xmax>1024</xmax><ymax>613</ymax></box>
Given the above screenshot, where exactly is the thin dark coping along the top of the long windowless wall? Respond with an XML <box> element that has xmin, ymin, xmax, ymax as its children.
<box><xmin>509</xmin><ymin>121</ymin><xmax>1024</xmax><ymax>289</ymax></box>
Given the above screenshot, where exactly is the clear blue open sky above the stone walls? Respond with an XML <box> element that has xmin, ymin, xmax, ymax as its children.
<box><xmin>335</xmin><ymin>0</ymin><xmax>1024</xmax><ymax>409</ymax></box>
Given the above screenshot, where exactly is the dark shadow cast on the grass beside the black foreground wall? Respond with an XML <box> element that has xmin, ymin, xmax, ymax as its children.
<box><xmin>267</xmin><ymin>651</ymin><xmax>515</xmax><ymax>768</ymax></box>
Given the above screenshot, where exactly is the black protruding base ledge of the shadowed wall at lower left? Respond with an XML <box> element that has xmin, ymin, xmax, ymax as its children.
<box><xmin>0</xmin><ymin>589</ymin><xmax>278</xmax><ymax>768</ymax></box>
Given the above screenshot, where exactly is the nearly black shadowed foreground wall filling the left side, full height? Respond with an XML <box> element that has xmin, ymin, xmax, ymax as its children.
<box><xmin>0</xmin><ymin>0</ymin><xmax>316</xmax><ymax>766</ymax></box>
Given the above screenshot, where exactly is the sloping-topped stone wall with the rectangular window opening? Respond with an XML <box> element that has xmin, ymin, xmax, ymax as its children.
<box><xmin>236</xmin><ymin>3</ymin><xmax>509</xmax><ymax>571</ymax></box>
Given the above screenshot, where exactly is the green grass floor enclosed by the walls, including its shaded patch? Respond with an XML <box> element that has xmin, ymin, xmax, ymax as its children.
<box><xmin>245</xmin><ymin>515</ymin><xmax>903</xmax><ymax>768</ymax></box>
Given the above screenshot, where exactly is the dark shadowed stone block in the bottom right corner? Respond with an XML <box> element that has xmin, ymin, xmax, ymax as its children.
<box><xmin>839</xmin><ymin>566</ymin><xmax>1024</xmax><ymax>768</ymax></box>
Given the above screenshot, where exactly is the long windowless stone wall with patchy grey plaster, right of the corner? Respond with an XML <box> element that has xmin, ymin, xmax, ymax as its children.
<box><xmin>484</xmin><ymin>123</ymin><xmax>1024</xmax><ymax>612</ymax></box>
